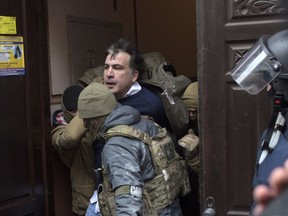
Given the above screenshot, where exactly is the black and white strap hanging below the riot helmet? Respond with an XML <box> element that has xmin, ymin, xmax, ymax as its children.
<box><xmin>257</xmin><ymin>93</ymin><xmax>287</xmax><ymax>165</ymax></box>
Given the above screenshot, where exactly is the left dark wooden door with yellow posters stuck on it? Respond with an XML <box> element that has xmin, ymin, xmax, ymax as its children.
<box><xmin>0</xmin><ymin>0</ymin><xmax>51</xmax><ymax>216</ymax></box>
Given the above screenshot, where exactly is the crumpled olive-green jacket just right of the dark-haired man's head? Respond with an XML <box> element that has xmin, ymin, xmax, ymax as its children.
<box><xmin>138</xmin><ymin>52</ymin><xmax>191</xmax><ymax>139</ymax></box>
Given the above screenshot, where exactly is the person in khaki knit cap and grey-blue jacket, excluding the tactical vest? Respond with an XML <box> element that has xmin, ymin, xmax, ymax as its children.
<box><xmin>78</xmin><ymin>83</ymin><xmax>182</xmax><ymax>216</ymax></box>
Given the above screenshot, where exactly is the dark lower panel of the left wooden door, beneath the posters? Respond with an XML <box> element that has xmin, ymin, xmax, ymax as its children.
<box><xmin>0</xmin><ymin>76</ymin><xmax>37</xmax><ymax>216</ymax></box>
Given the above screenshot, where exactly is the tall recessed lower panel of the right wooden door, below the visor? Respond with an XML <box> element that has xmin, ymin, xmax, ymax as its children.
<box><xmin>225</xmin><ymin>87</ymin><xmax>269</xmax><ymax>215</ymax></box>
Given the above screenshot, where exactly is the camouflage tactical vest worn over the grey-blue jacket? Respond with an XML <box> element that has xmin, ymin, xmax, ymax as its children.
<box><xmin>98</xmin><ymin>125</ymin><xmax>190</xmax><ymax>216</ymax></box>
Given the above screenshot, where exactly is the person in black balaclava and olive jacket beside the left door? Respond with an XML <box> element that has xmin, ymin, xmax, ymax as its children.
<box><xmin>51</xmin><ymin>85</ymin><xmax>96</xmax><ymax>215</ymax></box>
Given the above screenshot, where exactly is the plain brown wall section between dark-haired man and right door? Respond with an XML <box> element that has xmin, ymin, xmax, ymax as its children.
<box><xmin>136</xmin><ymin>0</ymin><xmax>197</xmax><ymax>77</ymax></box>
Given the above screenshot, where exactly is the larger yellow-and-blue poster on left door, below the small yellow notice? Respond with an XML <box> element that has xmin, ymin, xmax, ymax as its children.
<box><xmin>0</xmin><ymin>36</ymin><xmax>25</xmax><ymax>76</ymax></box>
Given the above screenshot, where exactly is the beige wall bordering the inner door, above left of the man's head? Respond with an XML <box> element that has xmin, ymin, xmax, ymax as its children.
<box><xmin>48</xmin><ymin>0</ymin><xmax>135</xmax><ymax>96</ymax></box>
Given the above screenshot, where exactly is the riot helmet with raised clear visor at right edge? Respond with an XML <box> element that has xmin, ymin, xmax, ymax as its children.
<box><xmin>231</xmin><ymin>29</ymin><xmax>288</xmax><ymax>95</ymax></box>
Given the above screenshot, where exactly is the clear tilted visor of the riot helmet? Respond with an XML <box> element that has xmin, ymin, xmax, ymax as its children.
<box><xmin>231</xmin><ymin>37</ymin><xmax>280</xmax><ymax>95</ymax></box>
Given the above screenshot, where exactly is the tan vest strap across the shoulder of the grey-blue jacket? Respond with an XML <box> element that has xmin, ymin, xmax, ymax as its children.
<box><xmin>102</xmin><ymin>125</ymin><xmax>152</xmax><ymax>145</ymax></box>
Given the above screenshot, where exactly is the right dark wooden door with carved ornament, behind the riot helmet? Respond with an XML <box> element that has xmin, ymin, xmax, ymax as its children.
<box><xmin>197</xmin><ymin>0</ymin><xmax>287</xmax><ymax>216</ymax></box>
